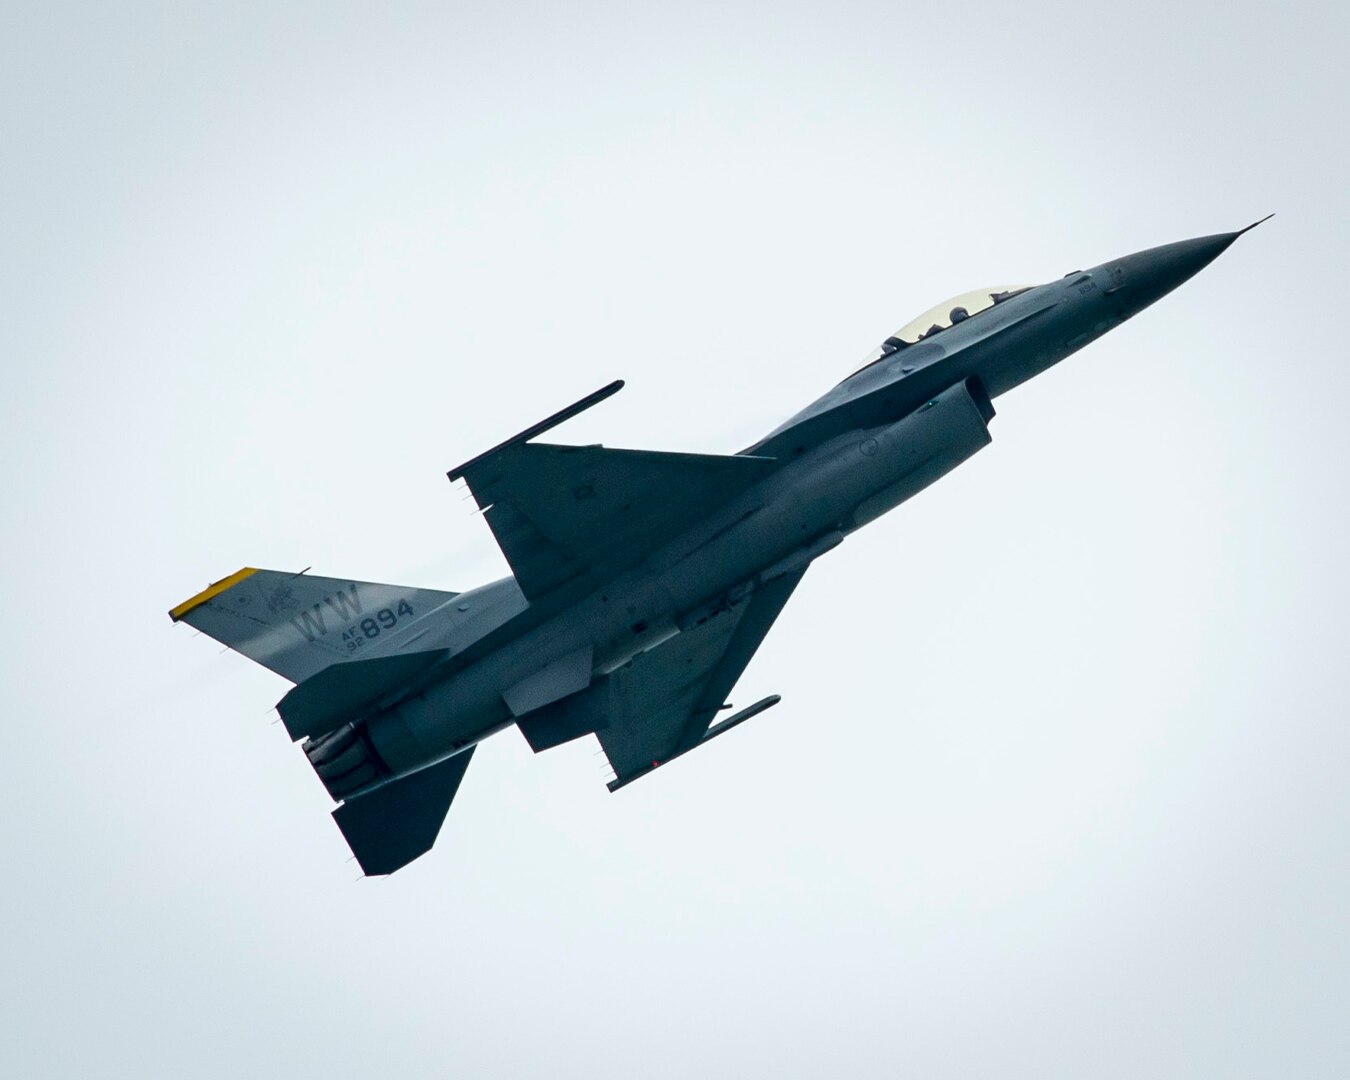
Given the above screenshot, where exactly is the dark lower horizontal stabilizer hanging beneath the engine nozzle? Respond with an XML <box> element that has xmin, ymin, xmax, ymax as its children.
<box><xmin>333</xmin><ymin>747</ymin><xmax>474</xmax><ymax>875</ymax></box>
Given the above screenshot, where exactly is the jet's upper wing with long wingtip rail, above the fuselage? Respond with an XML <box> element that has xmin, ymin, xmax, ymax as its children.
<box><xmin>448</xmin><ymin>383</ymin><xmax>776</xmax><ymax>599</ymax></box>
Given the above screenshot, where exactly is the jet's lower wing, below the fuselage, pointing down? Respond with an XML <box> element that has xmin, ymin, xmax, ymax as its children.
<box><xmin>595</xmin><ymin>568</ymin><xmax>806</xmax><ymax>791</ymax></box>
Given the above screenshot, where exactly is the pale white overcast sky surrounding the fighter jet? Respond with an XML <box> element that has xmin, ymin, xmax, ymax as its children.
<box><xmin>0</xmin><ymin>3</ymin><xmax>1350</xmax><ymax>1080</ymax></box>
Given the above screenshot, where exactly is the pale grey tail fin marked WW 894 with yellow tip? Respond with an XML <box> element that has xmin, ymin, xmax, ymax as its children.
<box><xmin>169</xmin><ymin>567</ymin><xmax>459</xmax><ymax>683</ymax></box>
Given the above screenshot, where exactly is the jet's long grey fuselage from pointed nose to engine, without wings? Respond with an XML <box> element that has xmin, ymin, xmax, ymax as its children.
<box><xmin>310</xmin><ymin>234</ymin><xmax>1234</xmax><ymax>798</ymax></box>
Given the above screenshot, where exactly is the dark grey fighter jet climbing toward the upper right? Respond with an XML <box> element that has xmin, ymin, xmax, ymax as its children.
<box><xmin>169</xmin><ymin>219</ymin><xmax>1265</xmax><ymax>875</ymax></box>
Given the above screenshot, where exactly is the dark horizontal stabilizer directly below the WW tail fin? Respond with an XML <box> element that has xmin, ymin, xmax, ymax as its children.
<box><xmin>277</xmin><ymin>649</ymin><xmax>450</xmax><ymax>740</ymax></box>
